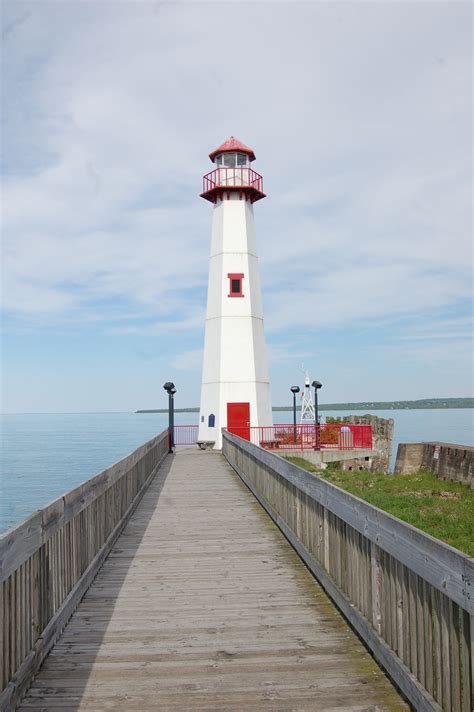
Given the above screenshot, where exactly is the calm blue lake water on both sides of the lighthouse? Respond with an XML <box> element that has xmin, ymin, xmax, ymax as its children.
<box><xmin>0</xmin><ymin>409</ymin><xmax>474</xmax><ymax>531</ymax></box>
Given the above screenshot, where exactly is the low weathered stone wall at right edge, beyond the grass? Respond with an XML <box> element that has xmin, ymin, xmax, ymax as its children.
<box><xmin>395</xmin><ymin>442</ymin><xmax>474</xmax><ymax>487</ymax></box>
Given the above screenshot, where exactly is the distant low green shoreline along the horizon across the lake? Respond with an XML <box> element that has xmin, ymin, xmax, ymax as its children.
<box><xmin>135</xmin><ymin>398</ymin><xmax>474</xmax><ymax>413</ymax></box>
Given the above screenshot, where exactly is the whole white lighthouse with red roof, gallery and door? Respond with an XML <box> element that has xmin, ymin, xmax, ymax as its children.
<box><xmin>198</xmin><ymin>136</ymin><xmax>272</xmax><ymax>448</ymax></box>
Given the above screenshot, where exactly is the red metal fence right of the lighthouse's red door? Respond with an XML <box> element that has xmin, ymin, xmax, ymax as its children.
<box><xmin>224</xmin><ymin>423</ymin><xmax>372</xmax><ymax>450</ymax></box>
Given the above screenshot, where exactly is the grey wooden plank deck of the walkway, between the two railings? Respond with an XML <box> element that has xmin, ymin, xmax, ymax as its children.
<box><xmin>19</xmin><ymin>450</ymin><xmax>408</xmax><ymax>712</ymax></box>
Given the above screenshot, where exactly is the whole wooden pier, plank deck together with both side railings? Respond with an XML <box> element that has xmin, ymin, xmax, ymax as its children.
<box><xmin>0</xmin><ymin>433</ymin><xmax>473</xmax><ymax>712</ymax></box>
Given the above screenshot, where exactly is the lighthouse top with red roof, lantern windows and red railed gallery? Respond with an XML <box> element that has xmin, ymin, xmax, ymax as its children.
<box><xmin>201</xmin><ymin>136</ymin><xmax>265</xmax><ymax>203</ymax></box>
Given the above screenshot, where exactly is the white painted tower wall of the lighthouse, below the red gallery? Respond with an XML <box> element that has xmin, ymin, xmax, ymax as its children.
<box><xmin>198</xmin><ymin>192</ymin><xmax>272</xmax><ymax>448</ymax></box>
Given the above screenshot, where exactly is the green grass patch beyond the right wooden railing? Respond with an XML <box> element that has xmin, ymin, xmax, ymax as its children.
<box><xmin>286</xmin><ymin>457</ymin><xmax>474</xmax><ymax>556</ymax></box>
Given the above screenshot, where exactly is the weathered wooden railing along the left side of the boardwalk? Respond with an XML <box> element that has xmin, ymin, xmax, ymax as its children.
<box><xmin>0</xmin><ymin>430</ymin><xmax>168</xmax><ymax>712</ymax></box>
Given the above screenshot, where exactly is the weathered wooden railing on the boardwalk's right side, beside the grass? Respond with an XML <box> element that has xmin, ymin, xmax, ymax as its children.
<box><xmin>223</xmin><ymin>433</ymin><xmax>474</xmax><ymax>712</ymax></box>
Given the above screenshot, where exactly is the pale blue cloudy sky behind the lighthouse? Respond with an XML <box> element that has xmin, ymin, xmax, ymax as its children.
<box><xmin>1</xmin><ymin>0</ymin><xmax>474</xmax><ymax>412</ymax></box>
